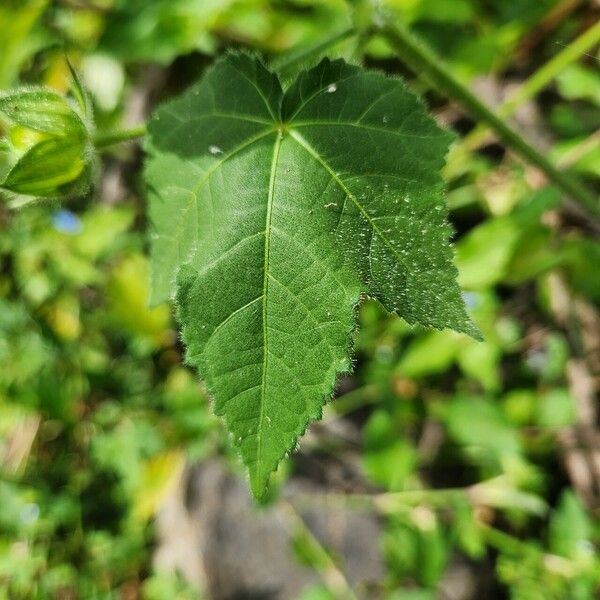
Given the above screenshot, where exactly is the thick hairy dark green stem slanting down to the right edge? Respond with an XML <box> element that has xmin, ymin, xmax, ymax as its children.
<box><xmin>378</xmin><ymin>22</ymin><xmax>600</xmax><ymax>220</ymax></box>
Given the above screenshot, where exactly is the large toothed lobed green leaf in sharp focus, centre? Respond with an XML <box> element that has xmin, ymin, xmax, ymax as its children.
<box><xmin>146</xmin><ymin>55</ymin><xmax>478</xmax><ymax>496</ymax></box>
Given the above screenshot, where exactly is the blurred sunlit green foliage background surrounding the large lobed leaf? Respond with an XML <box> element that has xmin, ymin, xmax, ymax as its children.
<box><xmin>0</xmin><ymin>0</ymin><xmax>600</xmax><ymax>600</ymax></box>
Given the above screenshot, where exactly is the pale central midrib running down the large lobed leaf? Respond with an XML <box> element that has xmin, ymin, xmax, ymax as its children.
<box><xmin>256</xmin><ymin>130</ymin><xmax>283</xmax><ymax>484</ymax></box>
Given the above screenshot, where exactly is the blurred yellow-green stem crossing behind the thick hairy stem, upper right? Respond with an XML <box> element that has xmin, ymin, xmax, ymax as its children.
<box><xmin>461</xmin><ymin>21</ymin><xmax>600</xmax><ymax>150</ymax></box>
